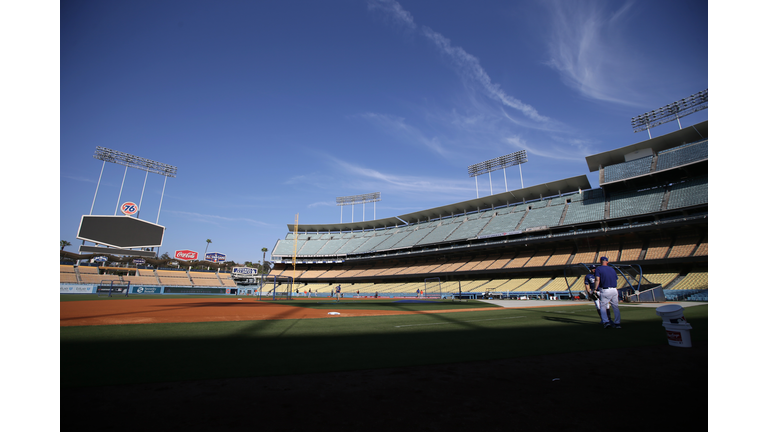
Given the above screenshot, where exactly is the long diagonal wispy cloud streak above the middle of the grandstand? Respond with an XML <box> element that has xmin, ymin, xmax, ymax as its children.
<box><xmin>366</xmin><ymin>0</ymin><xmax>604</xmax><ymax>160</ymax></box>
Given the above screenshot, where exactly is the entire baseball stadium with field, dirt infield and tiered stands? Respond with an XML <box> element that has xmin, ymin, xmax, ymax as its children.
<box><xmin>60</xmin><ymin>121</ymin><xmax>708</xmax><ymax>431</ymax></box>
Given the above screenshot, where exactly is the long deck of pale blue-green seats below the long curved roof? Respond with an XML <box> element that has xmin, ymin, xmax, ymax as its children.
<box><xmin>272</xmin><ymin>169</ymin><xmax>708</xmax><ymax>266</ymax></box>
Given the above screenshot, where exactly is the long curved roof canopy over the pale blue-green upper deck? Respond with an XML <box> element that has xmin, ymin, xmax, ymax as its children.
<box><xmin>288</xmin><ymin>175</ymin><xmax>592</xmax><ymax>232</ymax></box>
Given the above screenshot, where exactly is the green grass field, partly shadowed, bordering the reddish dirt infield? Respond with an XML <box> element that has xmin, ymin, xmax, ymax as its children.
<box><xmin>60</xmin><ymin>296</ymin><xmax>708</xmax><ymax>387</ymax></box>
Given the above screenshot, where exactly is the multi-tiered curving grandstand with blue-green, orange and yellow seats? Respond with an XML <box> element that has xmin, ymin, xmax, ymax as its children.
<box><xmin>269</xmin><ymin>121</ymin><xmax>708</xmax><ymax>301</ymax></box>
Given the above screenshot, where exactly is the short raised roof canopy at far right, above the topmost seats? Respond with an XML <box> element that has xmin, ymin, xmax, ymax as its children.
<box><xmin>587</xmin><ymin>120</ymin><xmax>709</xmax><ymax>172</ymax></box>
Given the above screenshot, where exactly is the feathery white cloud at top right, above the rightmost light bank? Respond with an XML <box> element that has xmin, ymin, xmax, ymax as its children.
<box><xmin>545</xmin><ymin>1</ymin><xmax>642</xmax><ymax>106</ymax></box>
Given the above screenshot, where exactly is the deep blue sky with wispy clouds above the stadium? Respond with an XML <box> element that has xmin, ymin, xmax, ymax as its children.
<box><xmin>58</xmin><ymin>0</ymin><xmax>709</xmax><ymax>262</ymax></box>
